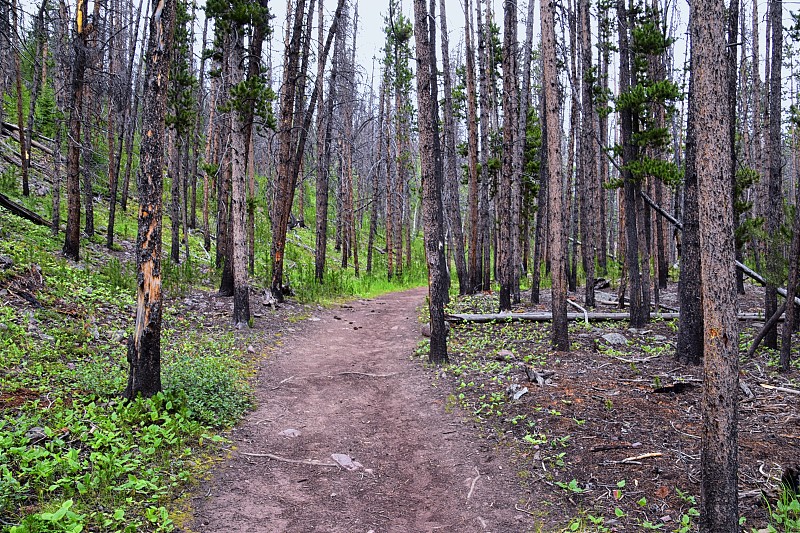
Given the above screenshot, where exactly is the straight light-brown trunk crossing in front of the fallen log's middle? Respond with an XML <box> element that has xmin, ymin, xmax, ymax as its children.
<box><xmin>541</xmin><ymin>0</ymin><xmax>569</xmax><ymax>352</ymax></box>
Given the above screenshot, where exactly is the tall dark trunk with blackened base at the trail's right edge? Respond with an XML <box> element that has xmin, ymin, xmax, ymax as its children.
<box><xmin>414</xmin><ymin>0</ymin><xmax>448</xmax><ymax>364</ymax></box>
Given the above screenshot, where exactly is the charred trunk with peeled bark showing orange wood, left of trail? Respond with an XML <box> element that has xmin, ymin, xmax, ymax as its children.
<box><xmin>125</xmin><ymin>0</ymin><xmax>176</xmax><ymax>398</ymax></box>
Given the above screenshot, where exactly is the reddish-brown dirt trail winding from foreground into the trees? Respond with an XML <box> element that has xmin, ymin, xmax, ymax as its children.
<box><xmin>192</xmin><ymin>289</ymin><xmax>531</xmax><ymax>533</ymax></box>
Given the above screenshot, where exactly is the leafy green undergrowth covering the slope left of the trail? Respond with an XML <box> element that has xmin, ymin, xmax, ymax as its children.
<box><xmin>0</xmin><ymin>211</ymin><xmax>253</xmax><ymax>533</ymax></box>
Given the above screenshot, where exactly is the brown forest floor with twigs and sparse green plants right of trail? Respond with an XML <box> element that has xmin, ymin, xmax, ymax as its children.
<box><xmin>447</xmin><ymin>284</ymin><xmax>800</xmax><ymax>531</ymax></box>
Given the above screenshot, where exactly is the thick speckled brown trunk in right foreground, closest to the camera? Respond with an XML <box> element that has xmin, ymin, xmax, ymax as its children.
<box><xmin>690</xmin><ymin>0</ymin><xmax>740</xmax><ymax>533</ymax></box>
